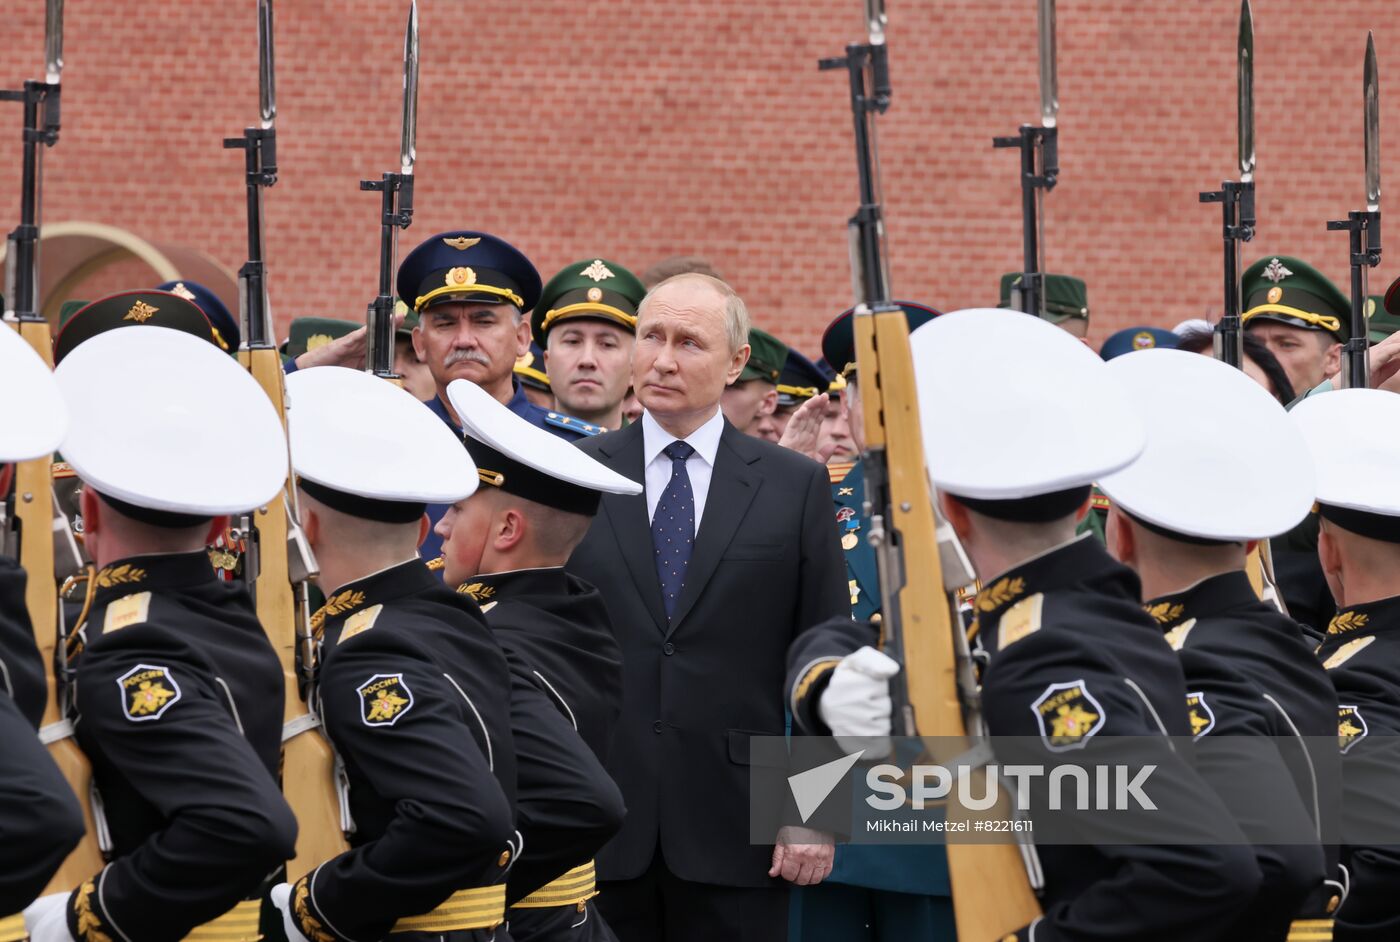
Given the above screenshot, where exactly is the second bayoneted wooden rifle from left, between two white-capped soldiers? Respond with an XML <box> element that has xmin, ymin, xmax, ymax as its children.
<box><xmin>224</xmin><ymin>0</ymin><xmax>347</xmax><ymax>880</ymax></box>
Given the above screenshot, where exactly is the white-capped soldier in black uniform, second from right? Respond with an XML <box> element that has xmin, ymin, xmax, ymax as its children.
<box><xmin>1099</xmin><ymin>350</ymin><xmax>1344</xmax><ymax>941</ymax></box>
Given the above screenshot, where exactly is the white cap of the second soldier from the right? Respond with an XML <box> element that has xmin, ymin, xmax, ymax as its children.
<box><xmin>1099</xmin><ymin>350</ymin><xmax>1316</xmax><ymax>542</ymax></box>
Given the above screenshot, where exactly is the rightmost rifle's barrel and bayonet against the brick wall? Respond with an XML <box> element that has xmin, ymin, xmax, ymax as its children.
<box><xmin>1327</xmin><ymin>32</ymin><xmax>1380</xmax><ymax>389</ymax></box>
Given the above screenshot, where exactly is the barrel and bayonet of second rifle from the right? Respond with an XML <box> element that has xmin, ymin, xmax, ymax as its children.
<box><xmin>1200</xmin><ymin>0</ymin><xmax>1254</xmax><ymax>370</ymax></box>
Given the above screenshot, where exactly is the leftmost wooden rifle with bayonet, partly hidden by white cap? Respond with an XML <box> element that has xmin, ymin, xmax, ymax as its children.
<box><xmin>0</xmin><ymin>0</ymin><xmax>104</xmax><ymax>893</ymax></box>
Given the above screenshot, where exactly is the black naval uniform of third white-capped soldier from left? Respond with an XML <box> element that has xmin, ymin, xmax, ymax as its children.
<box><xmin>291</xmin><ymin>558</ymin><xmax>529</xmax><ymax>942</ymax></box>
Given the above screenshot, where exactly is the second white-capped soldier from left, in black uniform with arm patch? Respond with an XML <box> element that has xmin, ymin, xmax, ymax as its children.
<box><xmin>27</xmin><ymin>319</ymin><xmax>297</xmax><ymax>942</ymax></box>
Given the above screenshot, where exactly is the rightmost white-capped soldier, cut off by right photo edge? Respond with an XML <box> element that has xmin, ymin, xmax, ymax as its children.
<box><xmin>1291</xmin><ymin>389</ymin><xmax>1400</xmax><ymax>942</ymax></box>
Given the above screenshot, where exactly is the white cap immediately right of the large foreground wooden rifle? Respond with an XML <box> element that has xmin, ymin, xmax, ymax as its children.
<box><xmin>910</xmin><ymin>308</ymin><xmax>1147</xmax><ymax>500</ymax></box>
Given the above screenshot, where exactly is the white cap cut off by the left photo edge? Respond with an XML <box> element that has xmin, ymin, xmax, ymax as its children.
<box><xmin>0</xmin><ymin>323</ymin><xmax>69</xmax><ymax>462</ymax></box>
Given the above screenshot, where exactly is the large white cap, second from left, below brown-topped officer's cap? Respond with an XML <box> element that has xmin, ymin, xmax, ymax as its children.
<box><xmin>53</xmin><ymin>328</ymin><xmax>287</xmax><ymax>516</ymax></box>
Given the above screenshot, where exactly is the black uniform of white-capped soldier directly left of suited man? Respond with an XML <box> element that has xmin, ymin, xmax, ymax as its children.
<box><xmin>458</xmin><ymin>567</ymin><xmax>626</xmax><ymax>942</ymax></box>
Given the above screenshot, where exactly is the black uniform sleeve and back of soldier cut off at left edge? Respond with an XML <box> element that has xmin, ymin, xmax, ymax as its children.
<box><xmin>0</xmin><ymin>556</ymin><xmax>83</xmax><ymax>918</ymax></box>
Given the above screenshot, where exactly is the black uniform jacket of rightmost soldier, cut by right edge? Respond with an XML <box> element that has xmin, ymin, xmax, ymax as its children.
<box><xmin>1317</xmin><ymin>596</ymin><xmax>1400</xmax><ymax>942</ymax></box>
